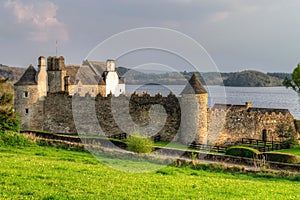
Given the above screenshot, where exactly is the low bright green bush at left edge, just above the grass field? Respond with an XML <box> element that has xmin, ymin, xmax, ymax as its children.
<box><xmin>0</xmin><ymin>131</ymin><xmax>33</xmax><ymax>147</ymax></box>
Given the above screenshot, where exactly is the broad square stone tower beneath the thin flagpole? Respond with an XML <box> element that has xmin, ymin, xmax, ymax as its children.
<box><xmin>47</xmin><ymin>56</ymin><xmax>66</xmax><ymax>93</ymax></box>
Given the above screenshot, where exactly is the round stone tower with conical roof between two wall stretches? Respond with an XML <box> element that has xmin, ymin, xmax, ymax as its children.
<box><xmin>179</xmin><ymin>73</ymin><xmax>208</xmax><ymax>144</ymax></box>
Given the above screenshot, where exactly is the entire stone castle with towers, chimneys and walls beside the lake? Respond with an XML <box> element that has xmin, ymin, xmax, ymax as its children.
<box><xmin>14</xmin><ymin>56</ymin><xmax>294</xmax><ymax>145</ymax></box>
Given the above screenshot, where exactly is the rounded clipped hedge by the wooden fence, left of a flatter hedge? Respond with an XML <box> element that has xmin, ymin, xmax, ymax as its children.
<box><xmin>226</xmin><ymin>146</ymin><xmax>260</xmax><ymax>158</ymax></box>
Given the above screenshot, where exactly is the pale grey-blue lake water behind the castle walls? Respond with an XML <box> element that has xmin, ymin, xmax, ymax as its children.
<box><xmin>126</xmin><ymin>85</ymin><xmax>300</xmax><ymax>119</ymax></box>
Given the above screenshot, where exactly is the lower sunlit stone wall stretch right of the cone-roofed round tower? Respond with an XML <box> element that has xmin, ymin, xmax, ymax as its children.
<box><xmin>208</xmin><ymin>109</ymin><xmax>295</xmax><ymax>145</ymax></box>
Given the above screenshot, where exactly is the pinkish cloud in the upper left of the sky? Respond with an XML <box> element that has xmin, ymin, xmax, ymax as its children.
<box><xmin>4</xmin><ymin>0</ymin><xmax>69</xmax><ymax>42</ymax></box>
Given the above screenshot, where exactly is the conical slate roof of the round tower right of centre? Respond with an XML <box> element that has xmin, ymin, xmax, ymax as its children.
<box><xmin>181</xmin><ymin>73</ymin><xmax>207</xmax><ymax>94</ymax></box>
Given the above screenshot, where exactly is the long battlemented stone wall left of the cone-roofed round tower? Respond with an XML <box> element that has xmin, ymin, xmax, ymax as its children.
<box><xmin>44</xmin><ymin>93</ymin><xmax>181</xmax><ymax>141</ymax></box>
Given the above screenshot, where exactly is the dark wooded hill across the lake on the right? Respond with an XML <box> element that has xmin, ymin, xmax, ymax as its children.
<box><xmin>223</xmin><ymin>70</ymin><xmax>282</xmax><ymax>87</ymax></box>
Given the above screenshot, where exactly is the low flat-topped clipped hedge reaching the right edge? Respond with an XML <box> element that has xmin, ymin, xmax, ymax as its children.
<box><xmin>263</xmin><ymin>152</ymin><xmax>300</xmax><ymax>163</ymax></box>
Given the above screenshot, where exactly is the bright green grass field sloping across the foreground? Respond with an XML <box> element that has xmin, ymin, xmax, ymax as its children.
<box><xmin>0</xmin><ymin>146</ymin><xmax>300</xmax><ymax>199</ymax></box>
